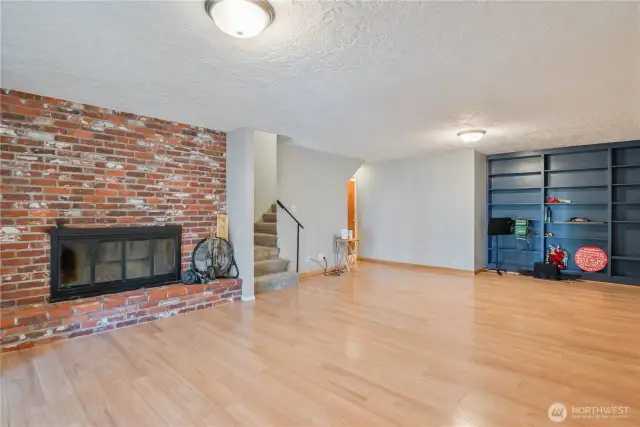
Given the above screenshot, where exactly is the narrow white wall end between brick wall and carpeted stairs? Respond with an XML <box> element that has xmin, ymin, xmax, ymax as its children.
<box><xmin>227</xmin><ymin>128</ymin><xmax>254</xmax><ymax>300</ymax></box>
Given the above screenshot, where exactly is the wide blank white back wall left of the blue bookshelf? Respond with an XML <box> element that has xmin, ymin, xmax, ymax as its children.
<box><xmin>357</xmin><ymin>149</ymin><xmax>484</xmax><ymax>270</ymax></box>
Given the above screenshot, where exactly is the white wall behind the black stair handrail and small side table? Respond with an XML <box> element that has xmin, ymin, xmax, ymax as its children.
<box><xmin>278</xmin><ymin>142</ymin><xmax>362</xmax><ymax>272</ymax></box>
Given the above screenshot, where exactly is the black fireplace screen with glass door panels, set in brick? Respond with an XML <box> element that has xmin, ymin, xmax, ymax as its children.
<box><xmin>51</xmin><ymin>226</ymin><xmax>181</xmax><ymax>301</ymax></box>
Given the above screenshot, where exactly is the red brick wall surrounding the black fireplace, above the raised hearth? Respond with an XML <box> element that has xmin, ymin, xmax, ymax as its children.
<box><xmin>0</xmin><ymin>89</ymin><xmax>226</xmax><ymax>307</ymax></box>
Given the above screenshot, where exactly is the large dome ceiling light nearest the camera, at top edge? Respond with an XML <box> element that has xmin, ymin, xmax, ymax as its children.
<box><xmin>204</xmin><ymin>0</ymin><xmax>275</xmax><ymax>39</ymax></box>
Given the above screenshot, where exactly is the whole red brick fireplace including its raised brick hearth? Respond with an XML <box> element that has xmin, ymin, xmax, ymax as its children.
<box><xmin>0</xmin><ymin>90</ymin><xmax>241</xmax><ymax>351</ymax></box>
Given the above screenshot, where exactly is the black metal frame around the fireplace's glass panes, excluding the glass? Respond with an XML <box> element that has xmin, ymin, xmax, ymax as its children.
<box><xmin>50</xmin><ymin>225</ymin><xmax>182</xmax><ymax>302</ymax></box>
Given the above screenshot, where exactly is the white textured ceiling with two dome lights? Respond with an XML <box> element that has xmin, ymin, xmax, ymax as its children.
<box><xmin>2</xmin><ymin>0</ymin><xmax>640</xmax><ymax>160</ymax></box>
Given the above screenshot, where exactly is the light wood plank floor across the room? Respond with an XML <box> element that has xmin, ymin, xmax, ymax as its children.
<box><xmin>0</xmin><ymin>263</ymin><xmax>640</xmax><ymax>427</ymax></box>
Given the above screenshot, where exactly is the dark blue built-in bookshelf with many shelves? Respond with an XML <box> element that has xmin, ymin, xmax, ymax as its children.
<box><xmin>486</xmin><ymin>141</ymin><xmax>640</xmax><ymax>285</ymax></box>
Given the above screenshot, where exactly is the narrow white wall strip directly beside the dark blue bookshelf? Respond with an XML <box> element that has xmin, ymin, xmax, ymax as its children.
<box><xmin>474</xmin><ymin>151</ymin><xmax>487</xmax><ymax>270</ymax></box>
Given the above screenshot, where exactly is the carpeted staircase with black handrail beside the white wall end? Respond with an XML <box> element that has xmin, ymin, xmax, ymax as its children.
<box><xmin>254</xmin><ymin>204</ymin><xmax>298</xmax><ymax>293</ymax></box>
